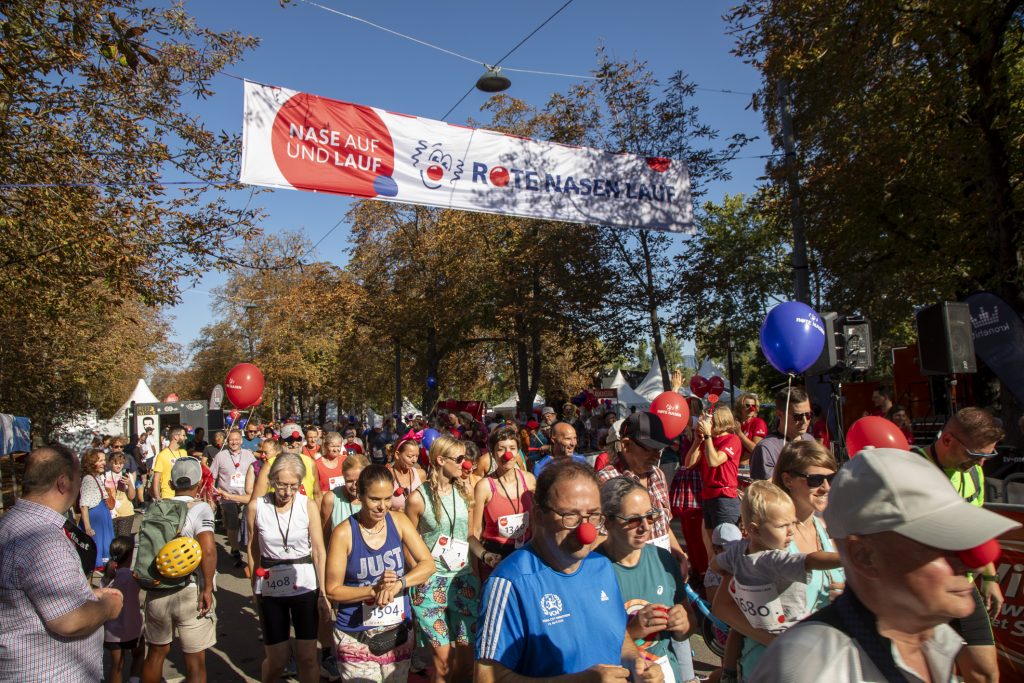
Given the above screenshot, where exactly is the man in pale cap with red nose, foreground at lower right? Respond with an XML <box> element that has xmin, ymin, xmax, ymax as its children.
<box><xmin>746</xmin><ymin>449</ymin><xmax>1020</xmax><ymax>683</ymax></box>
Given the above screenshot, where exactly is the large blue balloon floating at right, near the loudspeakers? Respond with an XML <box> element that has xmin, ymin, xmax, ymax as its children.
<box><xmin>761</xmin><ymin>301</ymin><xmax>825</xmax><ymax>374</ymax></box>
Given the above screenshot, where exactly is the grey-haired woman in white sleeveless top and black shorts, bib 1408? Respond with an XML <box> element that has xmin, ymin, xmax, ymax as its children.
<box><xmin>246</xmin><ymin>453</ymin><xmax>331</xmax><ymax>683</ymax></box>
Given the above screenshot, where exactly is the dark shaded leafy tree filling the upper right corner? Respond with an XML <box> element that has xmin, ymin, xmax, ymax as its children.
<box><xmin>730</xmin><ymin>0</ymin><xmax>1024</xmax><ymax>344</ymax></box>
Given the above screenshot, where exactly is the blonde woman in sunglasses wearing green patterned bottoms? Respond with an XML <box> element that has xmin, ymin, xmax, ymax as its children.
<box><xmin>406</xmin><ymin>436</ymin><xmax>480</xmax><ymax>683</ymax></box>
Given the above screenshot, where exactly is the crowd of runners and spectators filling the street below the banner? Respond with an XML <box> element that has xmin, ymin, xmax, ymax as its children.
<box><xmin>0</xmin><ymin>395</ymin><xmax>1015</xmax><ymax>683</ymax></box>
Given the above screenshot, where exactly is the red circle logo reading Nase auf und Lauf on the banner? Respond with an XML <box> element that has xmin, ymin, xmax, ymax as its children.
<box><xmin>270</xmin><ymin>93</ymin><xmax>398</xmax><ymax>197</ymax></box>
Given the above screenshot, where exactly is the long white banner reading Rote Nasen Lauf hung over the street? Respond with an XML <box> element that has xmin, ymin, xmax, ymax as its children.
<box><xmin>240</xmin><ymin>81</ymin><xmax>693</xmax><ymax>232</ymax></box>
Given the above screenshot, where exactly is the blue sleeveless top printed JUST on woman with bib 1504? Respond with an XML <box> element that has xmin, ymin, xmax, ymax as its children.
<box><xmin>335</xmin><ymin>513</ymin><xmax>413</xmax><ymax>631</ymax></box>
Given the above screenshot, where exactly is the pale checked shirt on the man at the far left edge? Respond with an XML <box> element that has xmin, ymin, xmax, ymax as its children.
<box><xmin>0</xmin><ymin>499</ymin><xmax>103</xmax><ymax>682</ymax></box>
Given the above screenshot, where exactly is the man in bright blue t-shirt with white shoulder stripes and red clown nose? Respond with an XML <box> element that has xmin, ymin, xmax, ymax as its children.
<box><xmin>474</xmin><ymin>460</ymin><xmax>663</xmax><ymax>683</ymax></box>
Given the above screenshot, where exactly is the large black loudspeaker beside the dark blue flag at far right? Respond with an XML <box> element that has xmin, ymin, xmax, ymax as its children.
<box><xmin>918</xmin><ymin>301</ymin><xmax>978</xmax><ymax>375</ymax></box>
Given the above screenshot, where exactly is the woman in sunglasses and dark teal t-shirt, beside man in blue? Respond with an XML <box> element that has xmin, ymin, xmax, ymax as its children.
<box><xmin>597</xmin><ymin>476</ymin><xmax>697</xmax><ymax>683</ymax></box>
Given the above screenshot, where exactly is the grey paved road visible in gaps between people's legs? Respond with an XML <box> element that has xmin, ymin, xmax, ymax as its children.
<box><xmin>121</xmin><ymin>533</ymin><xmax>719</xmax><ymax>683</ymax></box>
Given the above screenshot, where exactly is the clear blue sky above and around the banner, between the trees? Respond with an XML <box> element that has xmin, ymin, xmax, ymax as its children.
<box><xmin>169</xmin><ymin>0</ymin><xmax>772</xmax><ymax>366</ymax></box>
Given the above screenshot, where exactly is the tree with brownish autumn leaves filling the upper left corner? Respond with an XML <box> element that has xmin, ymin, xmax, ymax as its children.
<box><xmin>0</xmin><ymin>0</ymin><xmax>255</xmax><ymax>435</ymax></box>
